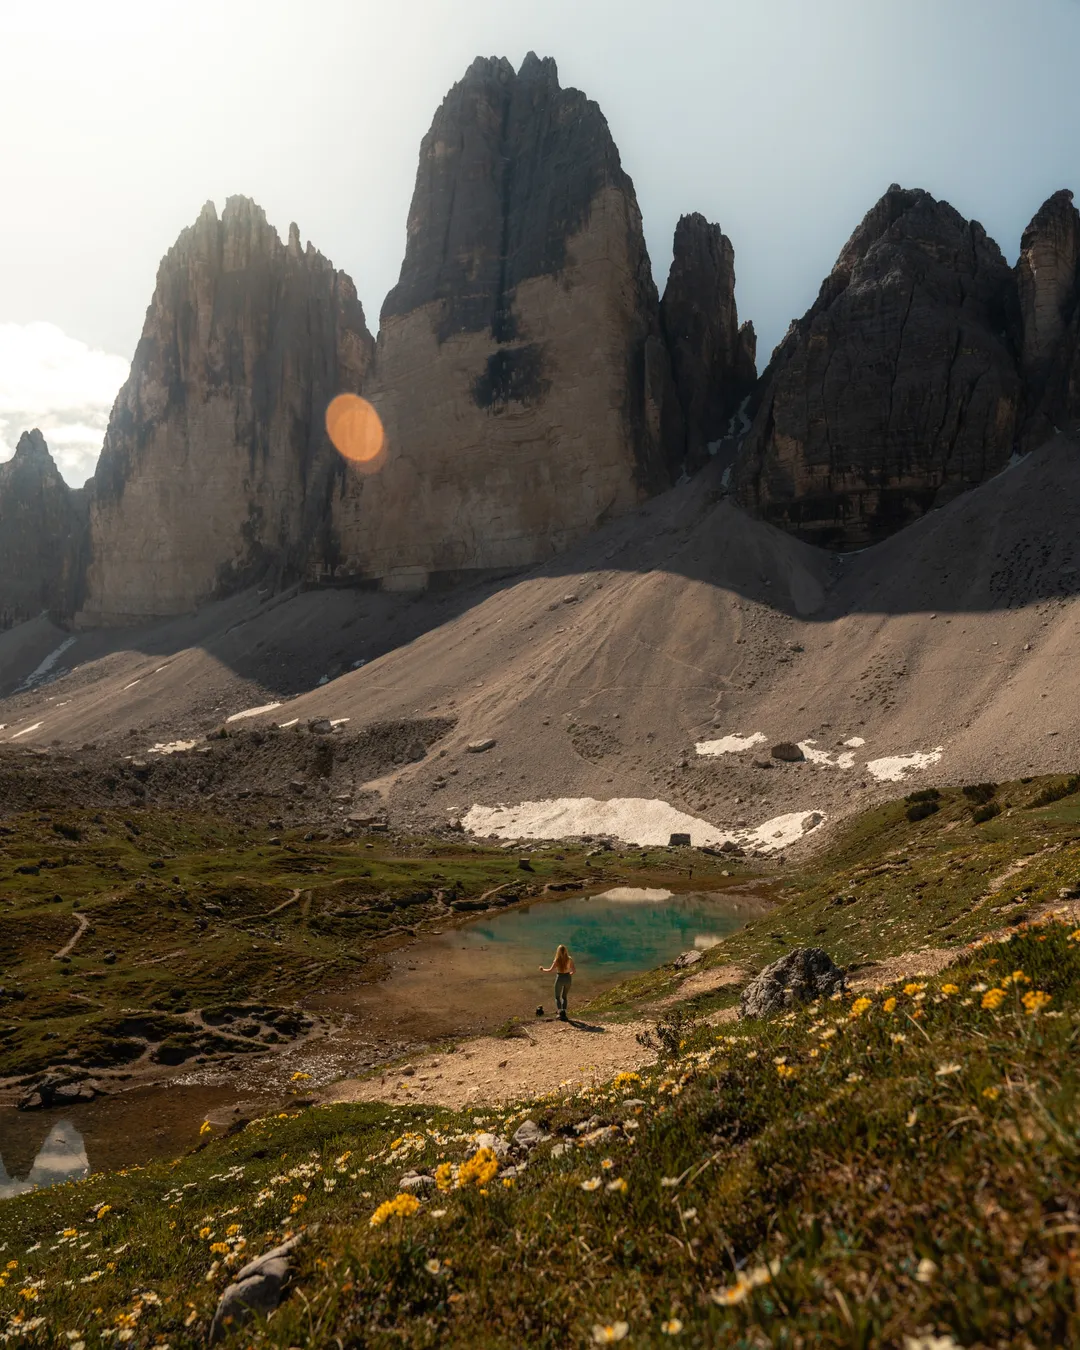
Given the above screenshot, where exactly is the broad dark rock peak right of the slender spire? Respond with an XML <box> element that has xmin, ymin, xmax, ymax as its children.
<box><xmin>737</xmin><ymin>186</ymin><xmax>1023</xmax><ymax>548</ymax></box>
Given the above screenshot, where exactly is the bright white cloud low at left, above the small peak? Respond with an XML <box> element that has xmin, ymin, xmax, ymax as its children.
<box><xmin>0</xmin><ymin>323</ymin><xmax>130</xmax><ymax>487</ymax></box>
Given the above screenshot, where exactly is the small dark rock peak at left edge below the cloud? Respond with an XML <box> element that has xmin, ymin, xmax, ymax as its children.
<box><xmin>0</xmin><ymin>431</ymin><xmax>86</xmax><ymax>629</ymax></box>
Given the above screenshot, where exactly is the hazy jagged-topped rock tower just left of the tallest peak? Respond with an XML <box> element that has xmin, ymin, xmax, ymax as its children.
<box><xmin>80</xmin><ymin>197</ymin><xmax>374</xmax><ymax>624</ymax></box>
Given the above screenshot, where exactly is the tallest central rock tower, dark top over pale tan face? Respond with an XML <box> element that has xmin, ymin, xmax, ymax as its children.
<box><xmin>332</xmin><ymin>54</ymin><xmax>682</xmax><ymax>586</ymax></box>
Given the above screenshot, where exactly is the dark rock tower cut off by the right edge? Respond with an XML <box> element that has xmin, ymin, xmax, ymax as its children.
<box><xmin>1017</xmin><ymin>190</ymin><xmax>1080</xmax><ymax>450</ymax></box>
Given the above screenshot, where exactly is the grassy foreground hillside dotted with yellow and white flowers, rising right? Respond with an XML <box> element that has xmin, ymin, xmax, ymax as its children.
<box><xmin>0</xmin><ymin>782</ymin><xmax>1080</xmax><ymax>1350</ymax></box>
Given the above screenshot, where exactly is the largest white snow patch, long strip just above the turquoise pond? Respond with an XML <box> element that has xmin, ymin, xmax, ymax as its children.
<box><xmin>462</xmin><ymin>797</ymin><xmax>825</xmax><ymax>853</ymax></box>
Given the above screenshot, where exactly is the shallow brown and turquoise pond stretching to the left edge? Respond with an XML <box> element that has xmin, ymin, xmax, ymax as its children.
<box><xmin>0</xmin><ymin>883</ymin><xmax>768</xmax><ymax>1199</ymax></box>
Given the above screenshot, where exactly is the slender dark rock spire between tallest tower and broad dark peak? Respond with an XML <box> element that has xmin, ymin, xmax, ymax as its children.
<box><xmin>660</xmin><ymin>213</ymin><xmax>757</xmax><ymax>468</ymax></box>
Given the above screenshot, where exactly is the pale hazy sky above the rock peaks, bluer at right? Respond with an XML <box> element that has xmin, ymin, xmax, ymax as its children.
<box><xmin>0</xmin><ymin>0</ymin><xmax>1080</xmax><ymax>482</ymax></box>
